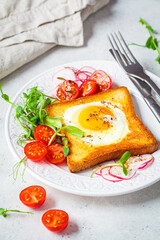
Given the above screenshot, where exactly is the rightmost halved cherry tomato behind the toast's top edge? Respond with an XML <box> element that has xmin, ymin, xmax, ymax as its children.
<box><xmin>90</xmin><ymin>70</ymin><xmax>112</xmax><ymax>91</ymax></box>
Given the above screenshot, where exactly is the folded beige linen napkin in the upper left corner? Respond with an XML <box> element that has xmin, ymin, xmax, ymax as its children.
<box><xmin>0</xmin><ymin>0</ymin><xmax>109</xmax><ymax>79</ymax></box>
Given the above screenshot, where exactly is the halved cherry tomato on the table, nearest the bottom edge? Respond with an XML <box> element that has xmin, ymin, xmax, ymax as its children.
<box><xmin>42</xmin><ymin>209</ymin><xmax>69</xmax><ymax>232</ymax></box>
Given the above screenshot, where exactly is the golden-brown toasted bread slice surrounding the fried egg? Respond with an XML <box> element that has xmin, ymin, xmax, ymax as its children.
<box><xmin>46</xmin><ymin>87</ymin><xmax>158</xmax><ymax>172</ymax></box>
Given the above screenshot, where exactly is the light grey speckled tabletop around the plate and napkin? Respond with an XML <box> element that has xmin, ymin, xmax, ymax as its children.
<box><xmin>0</xmin><ymin>0</ymin><xmax>160</xmax><ymax>240</ymax></box>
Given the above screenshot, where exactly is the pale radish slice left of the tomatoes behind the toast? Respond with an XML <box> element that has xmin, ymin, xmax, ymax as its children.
<box><xmin>52</xmin><ymin>68</ymin><xmax>76</xmax><ymax>97</ymax></box>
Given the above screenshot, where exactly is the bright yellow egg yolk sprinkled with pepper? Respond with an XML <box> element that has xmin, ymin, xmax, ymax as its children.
<box><xmin>79</xmin><ymin>106</ymin><xmax>114</xmax><ymax>131</ymax></box>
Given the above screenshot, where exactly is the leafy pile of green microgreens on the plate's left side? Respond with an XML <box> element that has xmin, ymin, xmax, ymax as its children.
<box><xmin>0</xmin><ymin>85</ymin><xmax>83</xmax><ymax>181</ymax></box>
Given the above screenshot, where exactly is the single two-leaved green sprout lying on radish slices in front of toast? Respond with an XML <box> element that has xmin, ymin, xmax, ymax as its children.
<box><xmin>90</xmin><ymin>151</ymin><xmax>131</xmax><ymax>178</ymax></box>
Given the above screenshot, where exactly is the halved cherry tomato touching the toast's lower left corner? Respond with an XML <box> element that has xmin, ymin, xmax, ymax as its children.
<box><xmin>46</xmin><ymin>143</ymin><xmax>65</xmax><ymax>164</ymax></box>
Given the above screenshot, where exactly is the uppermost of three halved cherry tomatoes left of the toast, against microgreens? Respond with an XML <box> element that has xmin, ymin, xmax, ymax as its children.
<box><xmin>34</xmin><ymin>125</ymin><xmax>56</xmax><ymax>145</ymax></box>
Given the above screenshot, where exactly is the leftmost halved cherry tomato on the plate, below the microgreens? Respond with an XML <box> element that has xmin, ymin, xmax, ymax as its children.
<box><xmin>24</xmin><ymin>141</ymin><xmax>47</xmax><ymax>162</ymax></box>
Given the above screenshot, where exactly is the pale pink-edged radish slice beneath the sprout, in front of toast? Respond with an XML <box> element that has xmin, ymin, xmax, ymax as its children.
<box><xmin>108</xmin><ymin>166</ymin><xmax>137</xmax><ymax>180</ymax></box>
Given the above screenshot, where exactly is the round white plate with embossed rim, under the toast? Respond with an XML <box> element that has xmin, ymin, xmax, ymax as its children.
<box><xmin>5</xmin><ymin>61</ymin><xmax>160</xmax><ymax>196</ymax></box>
